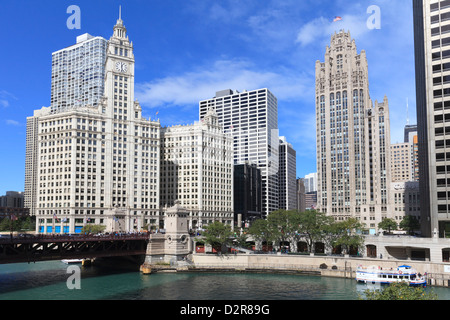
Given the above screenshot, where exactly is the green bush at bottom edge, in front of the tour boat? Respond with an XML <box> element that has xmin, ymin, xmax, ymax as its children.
<box><xmin>359</xmin><ymin>282</ymin><xmax>438</xmax><ymax>300</ymax></box>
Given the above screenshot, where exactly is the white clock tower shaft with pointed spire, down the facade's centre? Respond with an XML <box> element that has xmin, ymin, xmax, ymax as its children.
<box><xmin>101</xmin><ymin>11</ymin><xmax>138</xmax><ymax>218</ymax></box>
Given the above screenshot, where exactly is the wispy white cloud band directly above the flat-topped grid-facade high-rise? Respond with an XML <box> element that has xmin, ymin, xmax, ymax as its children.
<box><xmin>136</xmin><ymin>60</ymin><xmax>314</xmax><ymax>108</ymax></box>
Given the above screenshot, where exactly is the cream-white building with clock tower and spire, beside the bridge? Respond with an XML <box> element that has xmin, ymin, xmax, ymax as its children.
<box><xmin>26</xmin><ymin>13</ymin><xmax>160</xmax><ymax>233</ymax></box>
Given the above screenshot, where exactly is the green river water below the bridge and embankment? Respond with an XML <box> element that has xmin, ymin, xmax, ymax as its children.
<box><xmin>0</xmin><ymin>261</ymin><xmax>450</xmax><ymax>300</ymax></box>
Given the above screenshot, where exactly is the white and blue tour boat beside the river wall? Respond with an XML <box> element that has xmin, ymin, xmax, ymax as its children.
<box><xmin>356</xmin><ymin>265</ymin><xmax>427</xmax><ymax>287</ymax></box>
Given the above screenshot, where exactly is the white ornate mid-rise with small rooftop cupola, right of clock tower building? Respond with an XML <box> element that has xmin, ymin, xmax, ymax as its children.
<box><xmin>160</xmin><ymin>109</ymin><xmax>234</xmax><ymax>229</ymax></box>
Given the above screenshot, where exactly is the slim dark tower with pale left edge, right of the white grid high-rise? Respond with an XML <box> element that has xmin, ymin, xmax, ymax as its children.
<box><xmin>278</xmin><ymin>137</ymin><xmax>297</xmax><ymax>210</ymax></box>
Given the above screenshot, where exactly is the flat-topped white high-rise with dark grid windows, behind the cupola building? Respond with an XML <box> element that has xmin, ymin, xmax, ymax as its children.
<box><xmin>199</xmin><ymin>89</ymin><xmax>279</xmax><ymax>217</ymax></box>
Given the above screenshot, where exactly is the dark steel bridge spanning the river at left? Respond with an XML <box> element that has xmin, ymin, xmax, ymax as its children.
<box><xmin>0</xmin><ymin>233</ymin><xmax>150</xmax><ymax>264</ymax></box>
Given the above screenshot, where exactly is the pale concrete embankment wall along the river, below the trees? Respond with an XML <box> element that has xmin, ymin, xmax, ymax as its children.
<box><xmin>142</xmin><ymin>254</ymin><xmax>450</xmax><ymax>287</ymax></box>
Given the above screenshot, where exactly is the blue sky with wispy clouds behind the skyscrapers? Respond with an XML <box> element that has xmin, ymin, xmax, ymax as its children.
<box><xmin>0</xmin><ymin>0</ymin><xmax>416</xmax><ymax>195</ymax></box>
